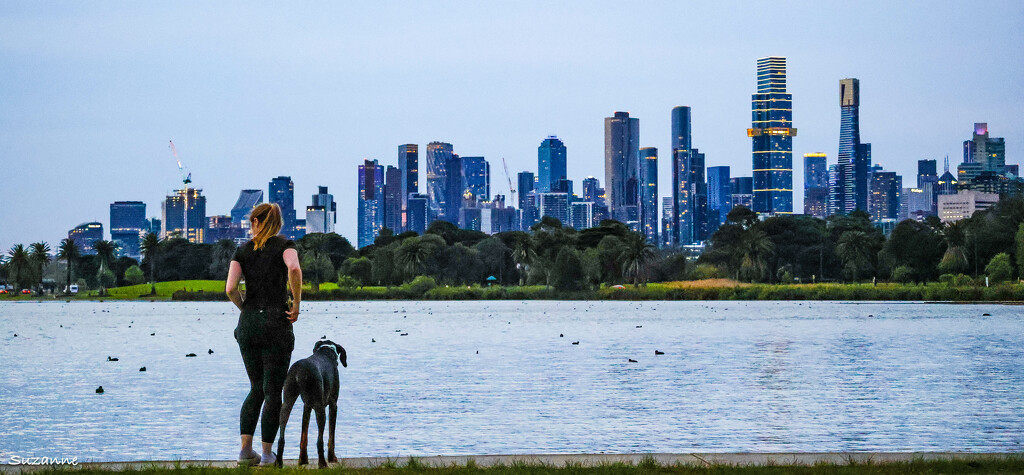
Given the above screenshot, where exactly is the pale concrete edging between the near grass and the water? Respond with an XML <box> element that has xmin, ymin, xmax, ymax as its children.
<box><xmin>0</xmin><ymin>452</ymin><xmax>1024</xmax><ymax>473</ymax></box>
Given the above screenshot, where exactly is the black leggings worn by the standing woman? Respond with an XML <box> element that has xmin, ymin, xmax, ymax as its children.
<box><xmin>234</xmin><ymin>310</ymin><xmax>295</xmax><ymax>443</ymax></box>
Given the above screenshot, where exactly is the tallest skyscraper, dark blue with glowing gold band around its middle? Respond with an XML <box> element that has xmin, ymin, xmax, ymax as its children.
<box><xmin>746</xmin><ymin>56</ymin><xmax>797</xmax><ymax>214</ymax></box>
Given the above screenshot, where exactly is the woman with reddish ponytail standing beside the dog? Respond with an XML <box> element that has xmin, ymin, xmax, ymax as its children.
<box><xmin>225</xmin><ymin>203</ymin><xmax>302</xmax><ymax>466</ymax></box>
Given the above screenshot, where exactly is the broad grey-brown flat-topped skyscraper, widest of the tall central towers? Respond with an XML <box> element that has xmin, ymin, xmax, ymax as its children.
<box><xmin>604</xmin><ymin>112</ymin><xmax>640</xmax><ymax>224</ymax></box>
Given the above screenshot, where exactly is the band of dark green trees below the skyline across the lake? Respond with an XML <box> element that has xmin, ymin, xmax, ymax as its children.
<box><xmin>6</xmin><ymin>199</ymin><xmax>1024</xmax><ymax>292</ymax></box>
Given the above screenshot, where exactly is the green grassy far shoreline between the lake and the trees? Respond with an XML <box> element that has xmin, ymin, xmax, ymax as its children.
<box><xmin>0</xmin><ymin>279</ymin><xmax>1024</xmax><ymax>303</ymax></box>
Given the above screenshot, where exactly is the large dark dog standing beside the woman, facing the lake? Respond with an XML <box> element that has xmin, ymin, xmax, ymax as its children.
<box><xmin>276</xmin><ymin>339</ymin><xmax>348</xmax><ymax>468</ymax></box>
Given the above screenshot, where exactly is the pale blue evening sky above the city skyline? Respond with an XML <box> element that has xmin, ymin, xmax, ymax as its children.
<box><xmin>0</xmin><ymin>0</ymin><xmax>1024</xmax><ymax>250</ymax></box>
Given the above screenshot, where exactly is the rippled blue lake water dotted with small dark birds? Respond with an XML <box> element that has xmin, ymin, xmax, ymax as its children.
<box><xmin>0</xmin><ymin>301</ymin><xmax>1024</xmax><ymax>463</ymax></box>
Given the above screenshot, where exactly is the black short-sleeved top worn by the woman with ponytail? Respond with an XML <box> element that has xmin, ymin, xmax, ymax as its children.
<box><xmin>232</xmin><ymin>235</ymin><xmax>295</xmax><ymax>310</ymax></box>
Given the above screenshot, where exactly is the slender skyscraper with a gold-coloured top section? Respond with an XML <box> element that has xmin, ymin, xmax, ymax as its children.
<box><xmin>836</xmin><ymin>78</ymin><xmax>871</xmax><ymax>214</ymax></box>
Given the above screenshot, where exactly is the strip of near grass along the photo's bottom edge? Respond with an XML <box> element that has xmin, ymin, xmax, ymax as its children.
<box><xmin>14</xmin><ymin>455</ymin><xmax>1024</xmax><ymax>475</ymax></box>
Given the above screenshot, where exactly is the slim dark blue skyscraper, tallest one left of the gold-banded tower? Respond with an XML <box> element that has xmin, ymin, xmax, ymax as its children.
<box><xmin>670</xmin><ymin>105</ymin><xmax>693</xmax><ymax>246</ymax></box>
